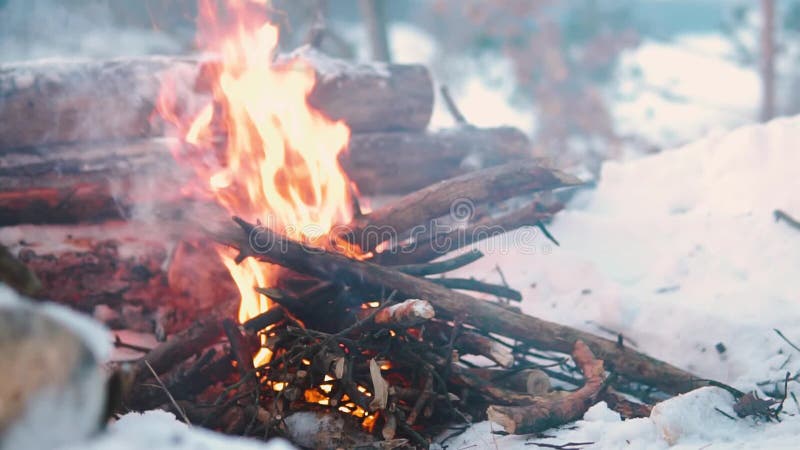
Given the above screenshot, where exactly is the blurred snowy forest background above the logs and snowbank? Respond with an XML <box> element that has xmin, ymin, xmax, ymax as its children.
<box><xmin>0</xmin><ymin>0</ymin><xmax>800</xmax><ymax>176</ymax></box>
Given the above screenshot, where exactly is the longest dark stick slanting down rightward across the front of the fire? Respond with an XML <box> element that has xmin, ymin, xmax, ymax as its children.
<box><xmin>223</xmin><ymin>218</ymin><xmax>708</xmax><ymax>393</ymax></box>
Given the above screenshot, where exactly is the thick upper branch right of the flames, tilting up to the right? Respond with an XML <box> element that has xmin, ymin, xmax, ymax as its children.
<box><xmin>346</xmin><ymin>161</ymin><xmax>581</xmax><ymax>251</ymax></box>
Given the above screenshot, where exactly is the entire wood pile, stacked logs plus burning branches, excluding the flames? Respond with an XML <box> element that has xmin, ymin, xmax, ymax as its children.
<box><xmin>0</xmin><ymin>50</ymin><xmax>705</xmax><ymax>448</ymax></box>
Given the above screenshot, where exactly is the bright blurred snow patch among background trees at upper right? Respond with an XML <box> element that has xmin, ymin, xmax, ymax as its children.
<box><xmin>612</xmin><ymin>33</ymin><xmax>761</xmax><ymax>148</ymax></box>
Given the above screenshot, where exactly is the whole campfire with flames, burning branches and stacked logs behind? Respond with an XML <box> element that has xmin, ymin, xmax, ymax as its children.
<box><xmin>0</xmin><ymin>0</ymin><xmax>724</xmax><ymax>448</ymax></box>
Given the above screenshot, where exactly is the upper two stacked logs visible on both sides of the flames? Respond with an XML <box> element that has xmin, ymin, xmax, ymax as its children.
<box><xmin>0</xmin><ymin>48</ymin><xmax>530</xmax><ymax>225</ymax></box>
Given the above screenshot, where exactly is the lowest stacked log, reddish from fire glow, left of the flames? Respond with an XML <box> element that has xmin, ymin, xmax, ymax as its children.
<box><xmin>0</xmin><ymin>222</ymin><xmax>239</xmax><ymax>336</ymax></box>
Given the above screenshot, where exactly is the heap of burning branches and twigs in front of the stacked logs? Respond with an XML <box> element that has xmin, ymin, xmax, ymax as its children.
<box><xmin>109</xmin><ymin>163</ymin><xmax>703</xmax><ymax>448</ymax></box>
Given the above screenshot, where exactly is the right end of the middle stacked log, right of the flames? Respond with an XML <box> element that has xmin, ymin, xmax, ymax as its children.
<box><xmin>342</xmin><ymin>127</ymin><xmax>533</xmax><ymax>194</ymax></box>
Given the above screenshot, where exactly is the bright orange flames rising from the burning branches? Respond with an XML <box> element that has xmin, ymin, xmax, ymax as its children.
<box><xmin>159</xmin><ymin>0</ymin><xmax>352</xmax><ymax>366</ymax></box>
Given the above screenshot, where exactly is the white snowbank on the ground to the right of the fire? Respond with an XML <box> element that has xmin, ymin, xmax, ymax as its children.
<box><xmin>438</xmin><ymin>117</ymin><xmax>800</xmax><ymax>449</ymax></box>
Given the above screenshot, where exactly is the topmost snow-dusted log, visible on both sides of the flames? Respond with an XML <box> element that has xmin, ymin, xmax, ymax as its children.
<box><xmin>0</xmin><ymin>48</ymin><xmax>433</xmax><ymax>150</ymax></box>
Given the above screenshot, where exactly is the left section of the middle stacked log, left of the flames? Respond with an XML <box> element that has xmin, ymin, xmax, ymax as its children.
<box><xmin>0</xmin><ymin>138</ymin><xmax>197</xmax><ymax>225</ymax></box>
